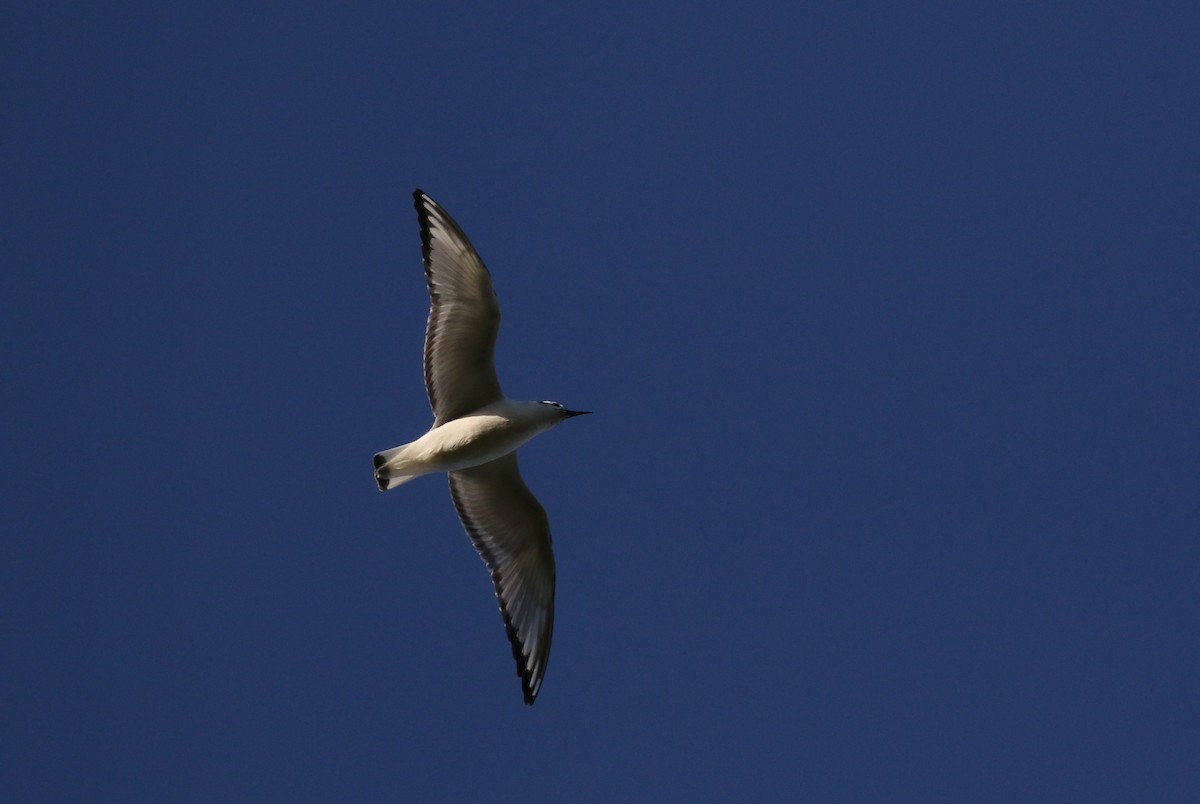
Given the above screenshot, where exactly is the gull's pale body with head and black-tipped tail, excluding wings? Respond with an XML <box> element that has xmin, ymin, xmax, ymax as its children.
<box><xmin>379</xmin><ymin>398</ymin><xmax>563</xmax><ymax>488</ymax></box>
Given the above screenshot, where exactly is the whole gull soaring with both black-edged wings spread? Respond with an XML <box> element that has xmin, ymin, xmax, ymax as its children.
<box><xmin>374</xmin><ymin>190</ymin><xmax>590</xmax><ymax>706</ymax></box>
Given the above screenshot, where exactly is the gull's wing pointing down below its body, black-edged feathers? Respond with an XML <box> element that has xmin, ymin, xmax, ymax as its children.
<box><xmin>450</xmin><ymin>452</ymin><xmax>554</xmax><ymax>704</ymax></box>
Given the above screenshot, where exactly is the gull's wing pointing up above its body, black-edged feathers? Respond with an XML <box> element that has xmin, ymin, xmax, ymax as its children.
<box><xmin>413</xmin><ymin>190</ymin><xmax>504</xmax><ymax>426</ymax></box>
